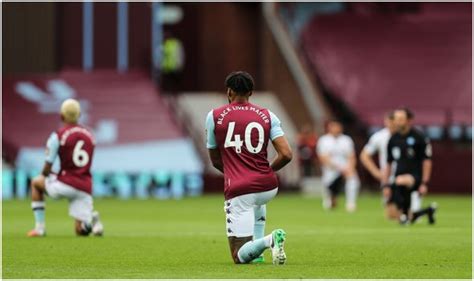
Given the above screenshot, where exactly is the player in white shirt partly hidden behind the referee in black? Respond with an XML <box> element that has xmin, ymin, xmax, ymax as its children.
<box><xmin>360</xmin><ymin>112</ymin><xmax>421</xmax><ymax>220</ymax></box>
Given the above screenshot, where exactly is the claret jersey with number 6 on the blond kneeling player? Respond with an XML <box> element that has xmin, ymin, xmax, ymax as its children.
<box><xmin>46</xmin><ymin>125</ymin><xmax>95</xmax><ymax>194</ymax></box>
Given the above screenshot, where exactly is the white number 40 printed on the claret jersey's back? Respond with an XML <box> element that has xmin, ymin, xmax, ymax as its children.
<box><xmin>224</xmin><ymin>122</ymin><xmax>264</xmax><ymax>153</ymax></box>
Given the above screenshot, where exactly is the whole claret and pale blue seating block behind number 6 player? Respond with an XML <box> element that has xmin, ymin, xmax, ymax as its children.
<box><xmin>2</xmin><ymin>70</ymin><xmax>202</xmax><ymax>172</ymax></box>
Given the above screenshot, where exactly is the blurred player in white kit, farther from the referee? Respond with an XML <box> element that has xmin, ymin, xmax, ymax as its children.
<box><xmin>317</xmin><ymin>120</ymin><xmax>360</xmax><ymax>212</ymax></box>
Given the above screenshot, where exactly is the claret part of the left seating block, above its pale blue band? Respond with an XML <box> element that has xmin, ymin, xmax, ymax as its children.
<box><xmin>3</xmin><ymin>70</ymin><xmax>182</xmax><ymax>146</ymax></box>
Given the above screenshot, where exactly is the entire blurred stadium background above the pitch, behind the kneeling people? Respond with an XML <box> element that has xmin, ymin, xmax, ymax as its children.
<box><xmin>2</xmin><ymin>2</ymin><xmax>472</xmax><ymax>200</ymax></box>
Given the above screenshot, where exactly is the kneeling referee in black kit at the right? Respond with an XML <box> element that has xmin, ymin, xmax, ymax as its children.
<box><xmin>382</xmin><ymin>108</ymin><xmax>436</xmax><ymax>224</ymax></box>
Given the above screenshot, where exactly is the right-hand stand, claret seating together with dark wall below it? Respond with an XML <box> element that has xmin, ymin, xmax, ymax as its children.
<box><xmin>279</xmin><ymin>3</ymin><xmax>472</xmax><ymax>193</ymax></box>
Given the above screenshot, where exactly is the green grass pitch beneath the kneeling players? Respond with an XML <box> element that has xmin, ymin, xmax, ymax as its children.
<box><xmin>2</xmin><ymin>194</ymin><xmax>472</xmax><ymax>278</ymax></box>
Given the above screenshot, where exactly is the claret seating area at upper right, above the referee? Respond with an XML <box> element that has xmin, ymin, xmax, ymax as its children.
<box><xmin>301</xmin><ymin>3</ymin><xmax>472</xmax><ymax>127</ymax></box>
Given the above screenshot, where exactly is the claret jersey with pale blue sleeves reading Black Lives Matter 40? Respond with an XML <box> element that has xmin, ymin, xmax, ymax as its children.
<box><xmin>206</xmin><ymin>102</ymin><xmax>284</xmax><ymax>200</ymax></box>
